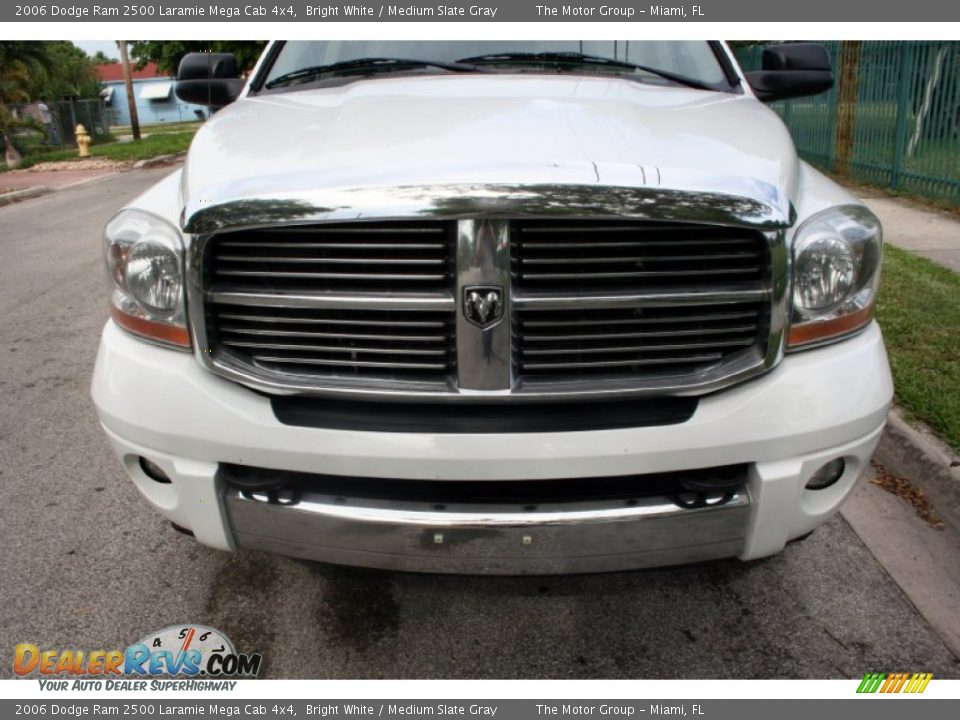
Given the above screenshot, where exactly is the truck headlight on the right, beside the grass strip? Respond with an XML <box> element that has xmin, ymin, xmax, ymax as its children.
<box><xmin>787</xmin><ymin>205</ymin><xmax>883</xmax><ymax>349</ymax></box>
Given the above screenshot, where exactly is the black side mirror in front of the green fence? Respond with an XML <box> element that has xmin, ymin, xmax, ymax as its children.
<box><xmin>746</xmin><ymin>43</ymin><xmax>833</xmax><ymax>102</ymax></box>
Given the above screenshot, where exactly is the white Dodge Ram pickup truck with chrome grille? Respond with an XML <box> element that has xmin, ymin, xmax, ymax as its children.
<box><xmin>92</xmin><ymin>41</ymin><xmax>892</xmax><ymax>574</ymax></box>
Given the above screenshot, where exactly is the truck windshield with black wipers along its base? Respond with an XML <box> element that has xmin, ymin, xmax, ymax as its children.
<box><xmin>257</xmin><ymin>40</ymin><xmax>728</xmax><ymax>91</ymax></box>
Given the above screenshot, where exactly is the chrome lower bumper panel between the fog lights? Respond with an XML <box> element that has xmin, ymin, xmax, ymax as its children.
<box><xmin>226</xmin><ymin>488</ymin><xmax>750</xmax><ymax>575</ymax></box>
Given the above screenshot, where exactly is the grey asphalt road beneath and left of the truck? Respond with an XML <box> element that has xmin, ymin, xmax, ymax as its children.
<box><xmin>0</xmin><ymin>170</ymin><xmax>960</xmax><ymax>678</ymax></box>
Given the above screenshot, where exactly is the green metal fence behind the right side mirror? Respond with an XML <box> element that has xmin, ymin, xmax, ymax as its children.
<box><xmin>736</xmin><ymin>41</ymin><xmax>960</xmax><ymax>204</ymax></box>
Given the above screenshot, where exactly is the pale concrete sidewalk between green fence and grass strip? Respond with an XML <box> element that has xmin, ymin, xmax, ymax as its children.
<box><xmin>860</xmin><ymin>193</ymin><xmax>960</xmax><ymax>272</ymax></box>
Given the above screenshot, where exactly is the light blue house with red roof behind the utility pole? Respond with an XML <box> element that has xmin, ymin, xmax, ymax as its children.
<box><xmin>96</xmin><ymin>62</ymin><xmax>208</xmax><ymax>125</ymax></box>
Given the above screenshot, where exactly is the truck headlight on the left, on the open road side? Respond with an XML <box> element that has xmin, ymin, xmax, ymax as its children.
<box><xmin>104</xmin><ymin>210</ymin><xmax>190</xmax><ymax>348</ymax></box>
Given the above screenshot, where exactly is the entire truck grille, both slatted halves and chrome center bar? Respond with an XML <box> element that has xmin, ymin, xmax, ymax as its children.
<box><xmin>199</xmin><ymin>218</ymin><xmax>786</xmax><ymax>400</ymax></box>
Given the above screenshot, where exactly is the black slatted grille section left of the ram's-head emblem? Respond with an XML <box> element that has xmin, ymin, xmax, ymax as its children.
<box><xmin>204</xmin><ymin>222</ymin><xmax>456</xmax><ymax>387</ymax></box>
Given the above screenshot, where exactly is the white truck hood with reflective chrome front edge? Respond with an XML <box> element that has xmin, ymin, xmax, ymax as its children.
<box><xmin>181</xmin><ymin>74</ymin><xmax>799</xmax><ymax>232</ymax></box>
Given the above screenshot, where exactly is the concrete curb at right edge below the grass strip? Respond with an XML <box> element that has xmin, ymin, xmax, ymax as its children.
<box><xmin>875</xmin><ymin>408</ymin><xmax>960</xmax><ymax>531</ymax></box>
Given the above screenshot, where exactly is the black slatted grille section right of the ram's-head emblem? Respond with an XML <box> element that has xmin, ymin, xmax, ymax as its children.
<box><xmin>510</xmin><ymin>220</ymin><xmax>769</xmax><ymax>380</ymax></box>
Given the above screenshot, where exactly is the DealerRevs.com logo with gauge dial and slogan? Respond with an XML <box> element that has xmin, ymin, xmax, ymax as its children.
<box><xmin>13</xmin><ymin>625</ymin><xmax>263</xmax><ymax>690</ymax></box>
